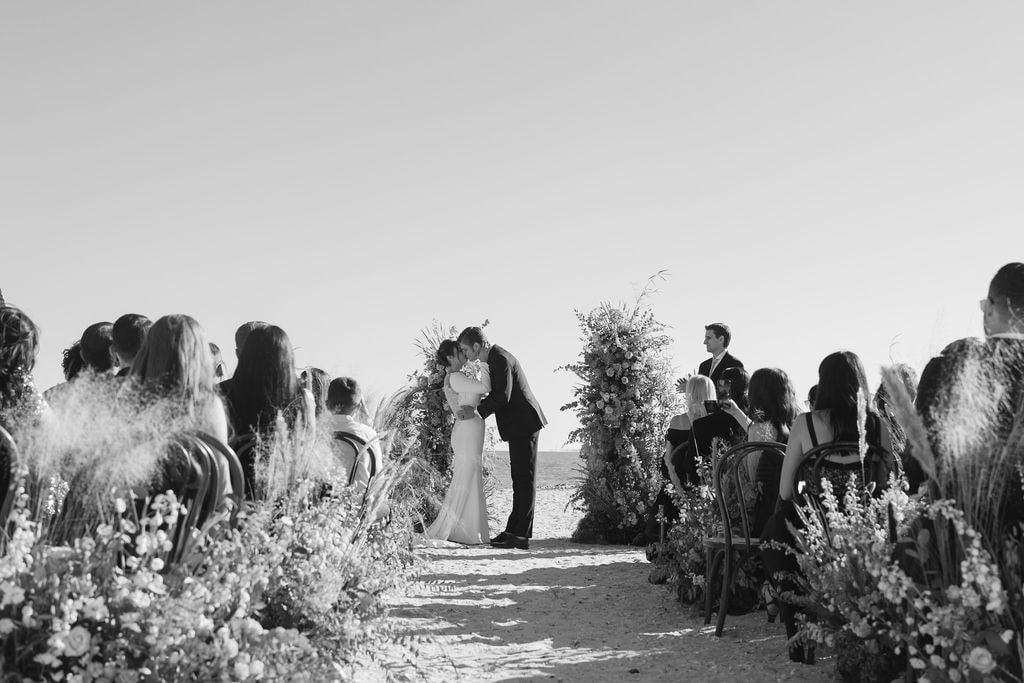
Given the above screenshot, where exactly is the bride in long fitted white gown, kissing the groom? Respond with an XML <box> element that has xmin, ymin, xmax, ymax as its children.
<box><xmin>424</xmin><ymin>339</ymin><xmax>490</xmax><ymax>545</ymax></box>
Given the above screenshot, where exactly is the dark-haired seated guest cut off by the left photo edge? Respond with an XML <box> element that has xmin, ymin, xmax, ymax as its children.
<box><xmin>0</xmin><ymin>304</ymin><xmax>46</xmax><ymax>436</ymax></box>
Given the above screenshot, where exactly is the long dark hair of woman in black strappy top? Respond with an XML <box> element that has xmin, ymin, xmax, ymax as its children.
<box><xmin>814</xmin><ymin>351</ymin><xmax>877</xmax><ymax>440</ymax></box>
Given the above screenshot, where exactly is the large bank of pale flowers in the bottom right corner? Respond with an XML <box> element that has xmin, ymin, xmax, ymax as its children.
<box><xmin>782</xmin><ymin>478</ymin><xmax>1019</xmax><ymax>682</ymax></box>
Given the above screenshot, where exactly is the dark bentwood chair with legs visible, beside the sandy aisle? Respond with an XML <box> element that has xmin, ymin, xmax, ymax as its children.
<box><xmin>703</xmin><ymin>441</ymin><xmax>785</xmax><ymax>636</ymax></box>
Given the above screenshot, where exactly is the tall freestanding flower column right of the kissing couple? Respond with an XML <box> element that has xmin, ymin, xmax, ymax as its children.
<box><xmin>561</xmin><ymin>288</ymin><xmax>678</xmax><ymax>543</ymax></box>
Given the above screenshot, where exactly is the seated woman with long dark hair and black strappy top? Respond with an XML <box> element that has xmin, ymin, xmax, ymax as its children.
<box><xmin>762</xmin><ymin>351</ymin><xmax>891</xmax><ymax>661</ymax></box>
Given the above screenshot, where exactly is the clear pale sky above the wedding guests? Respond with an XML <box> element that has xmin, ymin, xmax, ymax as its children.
<box><xmin>0</xmin><ymin>0</ymin><xmax>1024</xmax><ymax>450</ymax></box>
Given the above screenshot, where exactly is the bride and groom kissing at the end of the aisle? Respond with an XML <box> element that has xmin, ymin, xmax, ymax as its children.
<box><xmin>424</xmin><ymin>328</ymin><xmax>548</xmax><ymax>550</ymax></box>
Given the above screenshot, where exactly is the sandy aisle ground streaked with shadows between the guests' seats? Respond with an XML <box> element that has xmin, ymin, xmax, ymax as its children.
<box><xmin>356</xmin><ymin>488</ymin><xmax>833</xmax><ymax>682</ymax></box>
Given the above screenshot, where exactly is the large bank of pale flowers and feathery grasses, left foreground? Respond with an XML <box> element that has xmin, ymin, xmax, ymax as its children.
<box><xmin>0</xmin><ymin>384</ymin><xmax>416</xmax><ymax>681</ymax></box>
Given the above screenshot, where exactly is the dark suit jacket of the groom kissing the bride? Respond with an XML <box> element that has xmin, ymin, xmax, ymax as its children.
<box><xmin>476</xmin><ymin>344</ymin><xmax>548</xmax><ymax>441</ymax></box>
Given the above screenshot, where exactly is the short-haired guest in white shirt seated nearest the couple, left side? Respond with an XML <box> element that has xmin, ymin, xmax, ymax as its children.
<box><xmin>327</xmin><ymin>377</ymin><xmax>383</xmax><ymax>499</ymax></box>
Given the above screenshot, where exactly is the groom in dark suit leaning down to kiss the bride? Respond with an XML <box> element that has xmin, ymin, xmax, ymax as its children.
<box><xmin>458</xmin><ymin>328</ymin><xmax>548</xmax><ymax>550</ymax></box>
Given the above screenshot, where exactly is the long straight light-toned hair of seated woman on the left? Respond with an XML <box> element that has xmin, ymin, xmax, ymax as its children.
<box><xmin>129</xmin><ymin>314</ymin><xmax>214</xmax><ymax>405</ymax></box>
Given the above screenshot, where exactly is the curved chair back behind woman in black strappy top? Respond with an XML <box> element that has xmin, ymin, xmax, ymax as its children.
<box><xmin>792</xmin><ymin>441</ymin><xmax>893</xmax><ymax>507</ymax></box>
